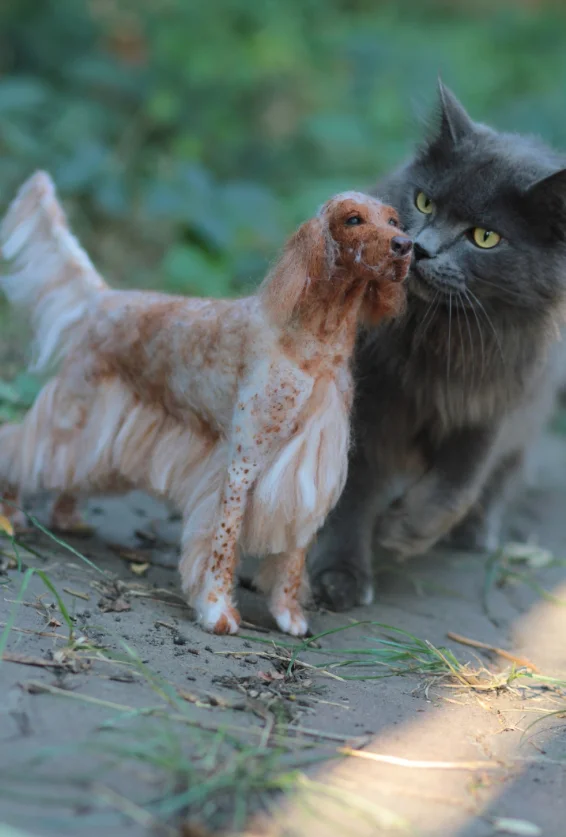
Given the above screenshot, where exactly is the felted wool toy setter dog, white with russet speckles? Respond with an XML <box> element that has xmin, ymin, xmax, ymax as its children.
<box><xmin>0</xmin><ymin>172</ymin><xmax>412</xmax><ymax>635</ymax></box>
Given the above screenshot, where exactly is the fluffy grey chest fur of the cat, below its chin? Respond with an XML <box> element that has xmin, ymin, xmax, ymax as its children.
<box><xmin>356</xmin><ymin>301</ymin><xmax>555</xmax><ymax>471</ymax></box>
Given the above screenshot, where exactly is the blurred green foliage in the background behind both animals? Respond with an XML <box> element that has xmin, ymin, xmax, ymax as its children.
<box><xmin>0</xmin><ymin>0</ymin><xmax>566</xmax><ymax>295</ymax></box>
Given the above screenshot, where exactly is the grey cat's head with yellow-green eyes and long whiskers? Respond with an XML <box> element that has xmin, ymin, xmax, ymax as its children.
<box><xmin>380</xmin><ymin>84</ymin><xmax>566</xmax><ymax>315</ymax></box>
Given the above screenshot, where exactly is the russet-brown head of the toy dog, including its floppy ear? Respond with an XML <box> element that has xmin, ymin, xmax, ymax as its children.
<box><xmin>264</xmin><ymin>192</ymin><xmax>412</xmax><ymax>324</ymax></box>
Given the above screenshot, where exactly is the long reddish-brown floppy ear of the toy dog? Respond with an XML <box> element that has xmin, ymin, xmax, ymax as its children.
<box><xmin>261</xmin><ymin>218</ymin><xmax>331</xmax><ymax>325</ymax></box>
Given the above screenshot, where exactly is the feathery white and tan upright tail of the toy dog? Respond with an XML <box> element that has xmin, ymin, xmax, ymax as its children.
<box><xmin>0</xmin><ymin>171</ymin><xmax>107</xmax><ymax>371</ymax></box>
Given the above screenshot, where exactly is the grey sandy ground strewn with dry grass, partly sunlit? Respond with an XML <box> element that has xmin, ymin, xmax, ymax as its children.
<box><xmin>0</xmin><ymin>428</ymin><xmax>566</xmax><ymax>837</ymax></box>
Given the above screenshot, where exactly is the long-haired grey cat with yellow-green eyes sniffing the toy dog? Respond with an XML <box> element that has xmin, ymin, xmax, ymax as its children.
<box><xmin>310</xmin><ymin>85</ymin><xmax>566</xmax><ymax>610</ymax></box>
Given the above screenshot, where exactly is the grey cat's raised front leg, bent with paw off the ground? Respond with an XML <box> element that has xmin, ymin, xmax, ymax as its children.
<box><xmin>377</xmin><ymin>427</ymin><xmax>492</xmax><ymax>558</ymax></box>
